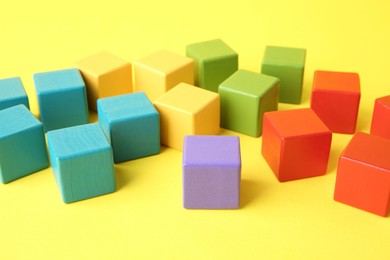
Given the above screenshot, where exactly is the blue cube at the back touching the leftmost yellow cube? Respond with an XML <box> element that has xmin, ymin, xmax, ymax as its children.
<box><xmin>34</xmin><ymin>69</ymin><xmax>88</xmax><ymax>132</ymax></box>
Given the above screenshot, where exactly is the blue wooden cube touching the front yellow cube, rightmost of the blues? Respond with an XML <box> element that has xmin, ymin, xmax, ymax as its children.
<box><xmin>97</xmin><ymin>92</ymin><xmax>160</xmax><ymax>163</ymax></box>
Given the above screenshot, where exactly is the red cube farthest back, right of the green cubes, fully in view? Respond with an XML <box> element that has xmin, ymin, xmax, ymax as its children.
<box><xmin>311</xmin><ymin>71</ymin><xmax>360</xmax><ymax>134</ymax></box>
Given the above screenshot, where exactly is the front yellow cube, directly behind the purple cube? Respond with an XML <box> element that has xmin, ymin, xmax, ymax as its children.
<box><xmin>154</xmin><ymin>83</ymin><xmax>220</xmax><ymax>151</ymax></box>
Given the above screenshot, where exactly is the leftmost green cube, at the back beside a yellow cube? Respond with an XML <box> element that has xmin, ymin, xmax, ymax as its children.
<box><xmin>186</xmin><ymin>39</ymin><xmax>238</xmax><ymax>93</ymax></box>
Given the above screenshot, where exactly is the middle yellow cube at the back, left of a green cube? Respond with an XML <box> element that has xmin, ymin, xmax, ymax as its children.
<box><xmin>133</xmin><ymin>50</ymin><xmax>194</xmax><ymax>102</ymax></box>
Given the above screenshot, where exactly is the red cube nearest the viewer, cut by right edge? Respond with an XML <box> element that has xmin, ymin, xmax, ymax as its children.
<box><xmin>334</xmin><ymin>132</ymin><xmax>390</xmax><ymax>217</ymax></box>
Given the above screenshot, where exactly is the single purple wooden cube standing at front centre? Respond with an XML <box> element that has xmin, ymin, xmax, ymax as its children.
<box><xmin>183</xmin><ymin>135</ymin><xmax>241</xmax><ymax>209</ymax></box>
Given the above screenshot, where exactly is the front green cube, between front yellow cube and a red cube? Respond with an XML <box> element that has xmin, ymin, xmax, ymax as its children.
<box><xmin>219</xmin><ymin>70</ymin><xmax>280</xmax><ymax>137</ymax></box>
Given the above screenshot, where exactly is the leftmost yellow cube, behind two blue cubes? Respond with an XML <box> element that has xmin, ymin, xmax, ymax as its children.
<box><xmin>76</xmin><ymin>52</ymin><xmax>133</xmax><ymax>111</ymax></box>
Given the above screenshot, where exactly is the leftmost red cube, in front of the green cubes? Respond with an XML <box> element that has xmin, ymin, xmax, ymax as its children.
<box><xmin>261</xmin><ymin>108</ymin><xmax>332</xmax><ymax>182</ymax></box>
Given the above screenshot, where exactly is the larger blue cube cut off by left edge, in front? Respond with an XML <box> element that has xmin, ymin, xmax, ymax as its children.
<box><xmin>0</xmin><ymin>105</ymin><xmax>49</xmax><ymax>183</ymax></box>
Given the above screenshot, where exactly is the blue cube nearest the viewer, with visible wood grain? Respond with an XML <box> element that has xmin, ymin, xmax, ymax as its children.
<box><xmin>47</xmin><ymin>123</ymin><xmax>115</xmax><ymax>203</ymax></box>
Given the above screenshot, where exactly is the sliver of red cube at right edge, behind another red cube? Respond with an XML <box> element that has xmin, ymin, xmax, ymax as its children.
<box><xmin>370</xmin><ymin>95</ymin><xmax>390</xmax><ymax>139</ymax></box>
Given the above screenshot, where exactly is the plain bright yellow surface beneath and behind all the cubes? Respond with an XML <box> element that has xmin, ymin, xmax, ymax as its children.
<box><xmin>0</xmin><ymin>0</ymin><xmax>390</xmax><ymax>259</ymax></box>
